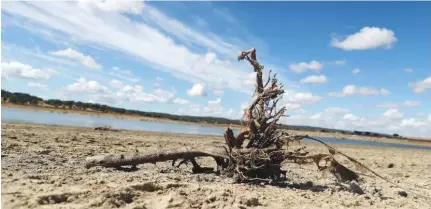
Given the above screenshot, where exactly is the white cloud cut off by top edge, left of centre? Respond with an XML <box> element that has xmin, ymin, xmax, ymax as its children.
<box><xmin>78</xmin><ymin>0</ymin><xmax>144</xmax><ymax>14</ymax></box>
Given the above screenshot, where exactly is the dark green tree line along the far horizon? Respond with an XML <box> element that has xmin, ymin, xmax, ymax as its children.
<box><xmin>1</xmin><ymin>89</ymin><xmax>401</xmax><ymax>138</ymax></box>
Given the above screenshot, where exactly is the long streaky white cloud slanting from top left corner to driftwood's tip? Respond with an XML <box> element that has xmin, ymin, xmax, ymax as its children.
<box><xmin>2</xmin><ymin>1</ymin><xmax>264</xmax><ymax>93</ymax></box>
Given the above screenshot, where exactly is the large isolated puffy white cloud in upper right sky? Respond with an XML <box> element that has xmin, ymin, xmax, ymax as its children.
<box><xmin>331</xmin><ymin>27</ymin><xmax>397</xmax><ymax>51</ymax></box>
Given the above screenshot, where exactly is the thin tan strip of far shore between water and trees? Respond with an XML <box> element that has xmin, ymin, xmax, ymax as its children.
<box><xmin>2</xmin><ymin>103</ymin><xmax>431</xmax><ymax>146</ymax></box>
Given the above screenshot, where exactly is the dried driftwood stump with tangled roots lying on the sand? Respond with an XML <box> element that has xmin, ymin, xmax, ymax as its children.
<box><xmin>86</xmin><ymin>48</ymin><xmax>428</xmax><ymax>199</ymax></box>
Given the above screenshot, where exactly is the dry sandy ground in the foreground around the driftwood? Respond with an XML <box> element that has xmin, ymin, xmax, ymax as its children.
<box><xmin>1</xmin><ymin>123</ymin><xmax>431</xmax><ymax>209</ymax></box>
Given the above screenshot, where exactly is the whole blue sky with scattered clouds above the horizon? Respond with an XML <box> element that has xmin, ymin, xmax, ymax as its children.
<box><xmin>1</xmin><ymin>0</ymin><xmax>431</xmax><ymax>137</ymax></box>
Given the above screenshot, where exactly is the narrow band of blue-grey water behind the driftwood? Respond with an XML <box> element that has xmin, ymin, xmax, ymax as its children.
<box><xmin>1</xmin><ymin>107</ymin><xmax>431</xmax><ymax>150</ymax></box>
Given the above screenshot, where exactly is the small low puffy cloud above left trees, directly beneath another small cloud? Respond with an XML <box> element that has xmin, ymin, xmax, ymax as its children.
<box><xmin>66</xmin><ymin>77</ymin><xmax>109</xmax><ymax>94</ymax></box>
